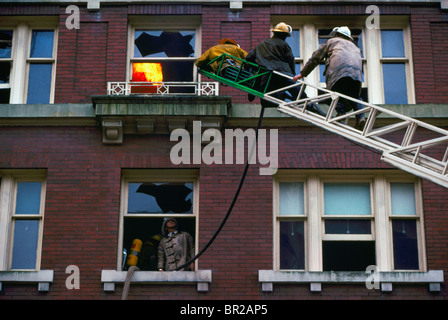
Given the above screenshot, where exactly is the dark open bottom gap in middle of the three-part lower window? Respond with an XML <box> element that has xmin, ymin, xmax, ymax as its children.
<box><xmin>322</xmin><ymin>241</ymin><xmax>376</xmax><ymax>271</ymax></box>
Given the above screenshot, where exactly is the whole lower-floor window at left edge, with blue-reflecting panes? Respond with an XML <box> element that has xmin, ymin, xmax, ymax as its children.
<box><xmin>0</xmin><ymin>172</ymin><xmax>45</xmax><ymax>270</ymax></box>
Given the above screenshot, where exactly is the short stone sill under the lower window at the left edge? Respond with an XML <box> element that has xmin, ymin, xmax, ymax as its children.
<box><xmin>0</xmin><ymin>270</ymin><xmax>53</xmax><ymax>292</ymax></box>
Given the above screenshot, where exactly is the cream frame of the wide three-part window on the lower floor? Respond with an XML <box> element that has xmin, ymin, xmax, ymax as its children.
<box><xmin>273</xmin><ymin>170</ymin><xmax>427</xmax><ymax>272</ymax></box>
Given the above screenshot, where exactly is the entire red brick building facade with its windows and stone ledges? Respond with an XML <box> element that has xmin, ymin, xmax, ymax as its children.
<box><xmin>0</xmin><ymin>1</ymin><xmax>448</xmax><ymax>300</ymax></box>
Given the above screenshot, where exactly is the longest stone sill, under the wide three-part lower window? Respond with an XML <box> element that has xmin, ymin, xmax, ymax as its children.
<box><xmin>258</xmin><ymin>270</ymin><xmax>443</xmax><ymax>292</ymax></box>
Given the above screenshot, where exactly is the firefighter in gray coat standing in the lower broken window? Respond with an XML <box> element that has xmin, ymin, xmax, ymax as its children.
<box><xmin>157</xmin><ymin>218</ymin><xmax>194</xmax><ymax>271</ymax></box>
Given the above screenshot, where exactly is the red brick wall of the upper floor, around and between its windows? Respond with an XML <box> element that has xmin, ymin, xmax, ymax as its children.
<box><xmin>49</xmin><ymin>4</ymin><xmax>448</xmax><ymax>103</ymax></box>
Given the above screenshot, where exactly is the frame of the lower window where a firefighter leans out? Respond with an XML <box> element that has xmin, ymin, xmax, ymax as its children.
<box><xmin>116</xmin><ymin>169</ymin><xmax>199</xmax><ymax>271</ymax></box>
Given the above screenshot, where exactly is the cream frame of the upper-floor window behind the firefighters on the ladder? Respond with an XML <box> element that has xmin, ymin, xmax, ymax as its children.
<box><xmin>272</xmin><ymin>15</ymin><xmax>416</xmax><ymax>104</ymax></box>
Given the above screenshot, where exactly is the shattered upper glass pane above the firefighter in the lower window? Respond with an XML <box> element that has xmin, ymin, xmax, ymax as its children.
<box><xmin>128</xmin><ymin>182</ymin><xmax>193</xmax><ymax>213</ymax></box>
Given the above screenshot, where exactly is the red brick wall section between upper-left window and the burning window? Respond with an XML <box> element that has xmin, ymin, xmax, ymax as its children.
<box><xmin>54</xmin><ymin>7</ymin><xmax>128</xmax><ymax>103</ymax></box>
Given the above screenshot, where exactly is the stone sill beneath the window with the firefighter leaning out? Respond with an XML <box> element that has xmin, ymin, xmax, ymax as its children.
<box><xmin>101</xmin><ymin>270</ymin><xmax>212</xmax><ymax>292</ymax></box>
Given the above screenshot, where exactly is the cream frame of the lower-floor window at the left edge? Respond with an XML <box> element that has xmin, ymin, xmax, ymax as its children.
<box><xmin>0</xmin><ymin>170</ymin><xmax>47</xmax><ymax>271</ymax></box>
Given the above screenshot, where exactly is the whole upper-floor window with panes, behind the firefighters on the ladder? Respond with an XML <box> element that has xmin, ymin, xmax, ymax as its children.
<box><xmin>273</xmin><ymin>16</ymin><xmax>415</xmax><ymax>104</ymax></box>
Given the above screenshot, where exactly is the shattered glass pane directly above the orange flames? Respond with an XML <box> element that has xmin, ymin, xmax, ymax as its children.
<box><xmin>134</xmin><ymin>30</ymin><xmax>196</xmax><ymax>58</ymax></box>
